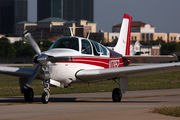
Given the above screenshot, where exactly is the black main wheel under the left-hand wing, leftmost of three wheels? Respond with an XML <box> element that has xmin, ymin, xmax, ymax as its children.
<box><xmin>24</xmin><ymin>88</ymin><xmax>34</xmax><ymax>102</ymax></box>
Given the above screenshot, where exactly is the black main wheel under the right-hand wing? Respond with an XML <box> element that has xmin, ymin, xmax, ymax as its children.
<box><xmin>112</xmin><ymin>88</ymin><xmax>122</xmax><ymax>102</ymax></box>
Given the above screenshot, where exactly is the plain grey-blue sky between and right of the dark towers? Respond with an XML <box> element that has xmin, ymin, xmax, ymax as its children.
<box><xmin>28</xmin><ymin>0</ymin><xmax>180</xmax><ymax>33</ymax></box>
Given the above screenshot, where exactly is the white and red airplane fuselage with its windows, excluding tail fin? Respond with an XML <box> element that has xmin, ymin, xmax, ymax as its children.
<box><xmin>32</xmin><ymin>37</ymin><xmax>123</xmax><ymax>84</ymax></box>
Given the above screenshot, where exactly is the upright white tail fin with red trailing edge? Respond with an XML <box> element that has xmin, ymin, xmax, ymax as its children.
<box><xmin>114</xmin><ymin>14</ymin><xmax>132</xmax><ymax>55</ymax></box>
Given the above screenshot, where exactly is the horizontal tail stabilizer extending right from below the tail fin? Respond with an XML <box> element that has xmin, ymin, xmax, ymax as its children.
<box><xmin>123</xmin><ymin>54</ymin><xmax>178</xmax><ymax>63</ymax></box>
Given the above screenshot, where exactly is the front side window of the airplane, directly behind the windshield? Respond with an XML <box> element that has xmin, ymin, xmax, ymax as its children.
<box><xmin>81</xmin><ymin>39</ymin><xmax>92</xmax><ymax>54</ymax></box>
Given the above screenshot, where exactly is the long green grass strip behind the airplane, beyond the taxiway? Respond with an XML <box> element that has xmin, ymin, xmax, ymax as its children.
<box><xmin>0</xmin><ymin>66</ymin><xmax>180</xmax><ymax>96</ymax></box>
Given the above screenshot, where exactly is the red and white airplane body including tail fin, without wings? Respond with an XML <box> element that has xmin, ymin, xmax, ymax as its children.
<box><xmin>34</xmin><ymin>14</ymin><xmax>132</xmax><ymax>84</ymax></box>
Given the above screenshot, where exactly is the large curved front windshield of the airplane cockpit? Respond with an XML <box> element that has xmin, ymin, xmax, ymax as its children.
<box><xmin>49</xmin><ymin>37</ymin><xmax>79</xmax><ymax>51</ymax></box>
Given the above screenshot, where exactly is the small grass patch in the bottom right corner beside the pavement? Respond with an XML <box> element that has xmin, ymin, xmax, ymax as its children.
<box><xmin>151</xmin><ymin>107</ymin><xmax>180</xmax><ymax>117</ymax></box>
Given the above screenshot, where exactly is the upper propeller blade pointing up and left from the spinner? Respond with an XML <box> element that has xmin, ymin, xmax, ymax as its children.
<box><xmin>24</xmin><ymin>30</ymin><xmax>41</xmax><ymax>56</ymax></box>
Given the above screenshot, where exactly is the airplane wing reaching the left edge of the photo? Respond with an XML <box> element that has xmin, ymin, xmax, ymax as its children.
<box><xmin>0</xmin><ymin>66</ymin><xmax>34</xmax><ymax>77</ymax></box>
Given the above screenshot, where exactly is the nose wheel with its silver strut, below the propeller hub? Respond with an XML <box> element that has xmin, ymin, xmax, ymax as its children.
<box><xmin>41</xmin><ymin>80</ymin><xmax>50</xmax><ymax>104</ymax></box>
